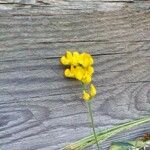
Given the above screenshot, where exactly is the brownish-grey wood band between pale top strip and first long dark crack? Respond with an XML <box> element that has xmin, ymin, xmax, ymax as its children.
<box><xmin>0</xmin><ymin>9</ymin><xmax>150</xmax><ymax>47</ymax></box>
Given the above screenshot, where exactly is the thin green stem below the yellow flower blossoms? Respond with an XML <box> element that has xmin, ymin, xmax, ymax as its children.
<box><xmin>87</xmin><ymin>102</ymin><xmax>100</xmax><ymax>150</ymax></box>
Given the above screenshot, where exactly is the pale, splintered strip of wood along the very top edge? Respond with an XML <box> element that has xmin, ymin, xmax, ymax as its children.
<box><xmin>0</xmin><ymin>0</ymin><xmax>150</xmax><ymax>15</ymax></box>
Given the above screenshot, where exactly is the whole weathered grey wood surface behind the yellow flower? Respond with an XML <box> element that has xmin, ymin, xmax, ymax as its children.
<box><xmin>0</xmin><ymin>0</ymin><xmax>150</xmax><ymax>150</ymax></box>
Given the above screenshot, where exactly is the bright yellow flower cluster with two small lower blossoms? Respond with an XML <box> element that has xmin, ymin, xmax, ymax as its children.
<box><xmin>60</xmin><ymin>51</ymin><xmax>96</xmax><ymax>101</ymax></box>
